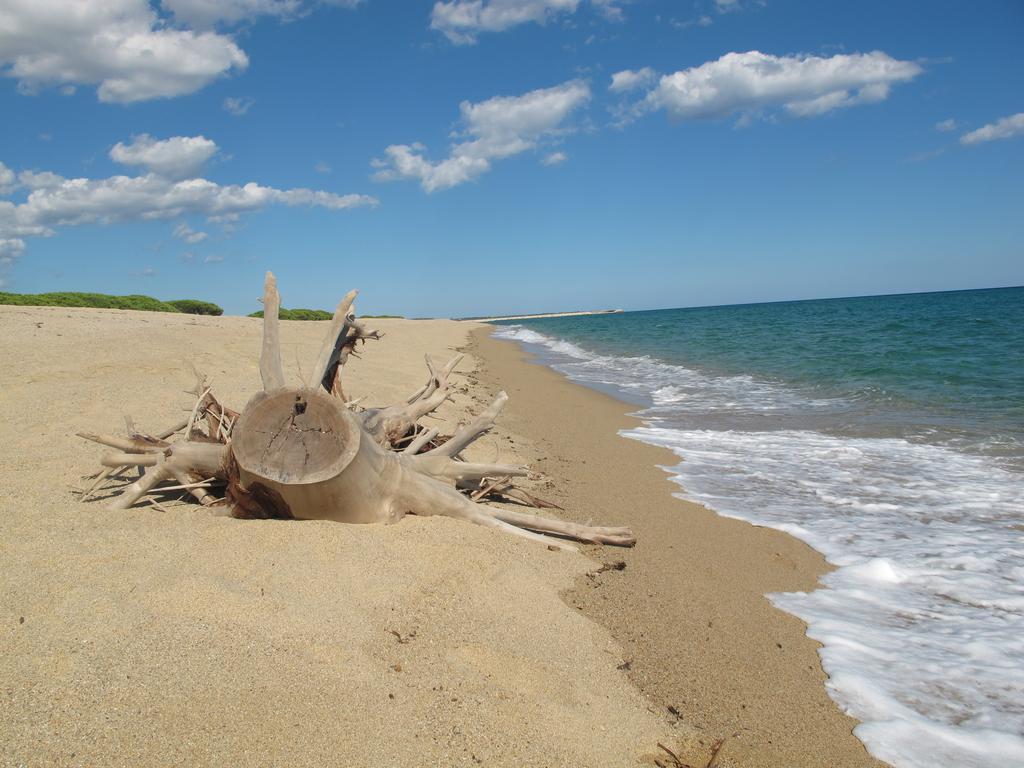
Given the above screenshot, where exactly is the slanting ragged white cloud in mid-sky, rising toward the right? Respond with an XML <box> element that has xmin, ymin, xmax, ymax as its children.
<box><xmin>373</xmin><ymin>80</ymin><xmax>590</xmax><ymax>193</ymax></box>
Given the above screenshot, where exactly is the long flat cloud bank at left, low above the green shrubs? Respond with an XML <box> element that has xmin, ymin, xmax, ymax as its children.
<box><xmin>0</xmin><ymin>148</ymin><xmax>378</xmax><ymax>278</ymax></box>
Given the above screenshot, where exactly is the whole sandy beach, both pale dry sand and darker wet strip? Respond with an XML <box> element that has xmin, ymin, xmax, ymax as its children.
<box><xmin>0</xmin><ymin>306</ymin><xmax>873</xmax><ymax>767</ymax></box>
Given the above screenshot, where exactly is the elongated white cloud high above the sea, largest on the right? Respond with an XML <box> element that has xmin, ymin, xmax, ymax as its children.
<box><xmin>624</xmin><ymin>51</ymin><xmax>923</xmax><ymax>120</ymax></box>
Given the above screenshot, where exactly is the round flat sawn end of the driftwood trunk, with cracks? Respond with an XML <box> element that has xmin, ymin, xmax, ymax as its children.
<box><xmin>231</xmin><ymin>387</ymin><xmax>360</xmax><ymax>485</ymax></box>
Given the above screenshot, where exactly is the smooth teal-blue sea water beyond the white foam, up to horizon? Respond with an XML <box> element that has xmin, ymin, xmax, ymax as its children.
<box><xmin>499</xmin><ymin>288</ymin><xmax>1024</xmax><ymax>466</ymax></box>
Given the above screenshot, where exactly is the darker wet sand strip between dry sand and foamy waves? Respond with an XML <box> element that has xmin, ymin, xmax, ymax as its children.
<box><xmin>470</xmin><ymin>328</ymin><xmax>885</xmax><ymax>768</ymax></box>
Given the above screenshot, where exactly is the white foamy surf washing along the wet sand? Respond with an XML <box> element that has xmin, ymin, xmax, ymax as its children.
<box><xmin>496</xmin><ymin>326</ymin><xmax>1024</xmax><ymax>768</ymax></box>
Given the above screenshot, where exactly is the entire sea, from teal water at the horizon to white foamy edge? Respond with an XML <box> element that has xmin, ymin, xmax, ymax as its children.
<box><xmin>496</xmin><ymin>288</ymin><xmax>1024</xmax><ymax>768</ymax></box>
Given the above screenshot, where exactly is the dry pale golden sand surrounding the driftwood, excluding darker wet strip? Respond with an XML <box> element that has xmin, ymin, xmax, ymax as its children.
<box><xmin>0</xmin><ymin>307</ymin><xmax>682</xmax><ymax>766</ymax></box>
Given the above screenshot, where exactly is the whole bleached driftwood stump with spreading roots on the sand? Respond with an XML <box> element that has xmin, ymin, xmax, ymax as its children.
<box><xmin>80</xmin><ymin>272</ymin><xmax>636</xmax><ymax>549</ymax></box>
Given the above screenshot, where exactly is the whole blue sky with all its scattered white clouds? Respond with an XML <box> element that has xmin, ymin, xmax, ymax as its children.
<box><xmin>0</xmin><ymin>0</ymin><xmax>1024</xmax><ymax>316</ymax></box>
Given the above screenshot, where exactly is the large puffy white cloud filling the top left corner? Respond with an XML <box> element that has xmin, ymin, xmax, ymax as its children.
<box><xmin>0</xmin><ymin>0</ymin><xmax>249</xmax><ymax>102</ymax></box>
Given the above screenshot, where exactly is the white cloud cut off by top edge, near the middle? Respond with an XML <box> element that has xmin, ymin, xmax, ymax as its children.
<box><xmin>430</xmin><ymin>0</ymin><xmax>628</xmax><ymax>45</ymax></box>
